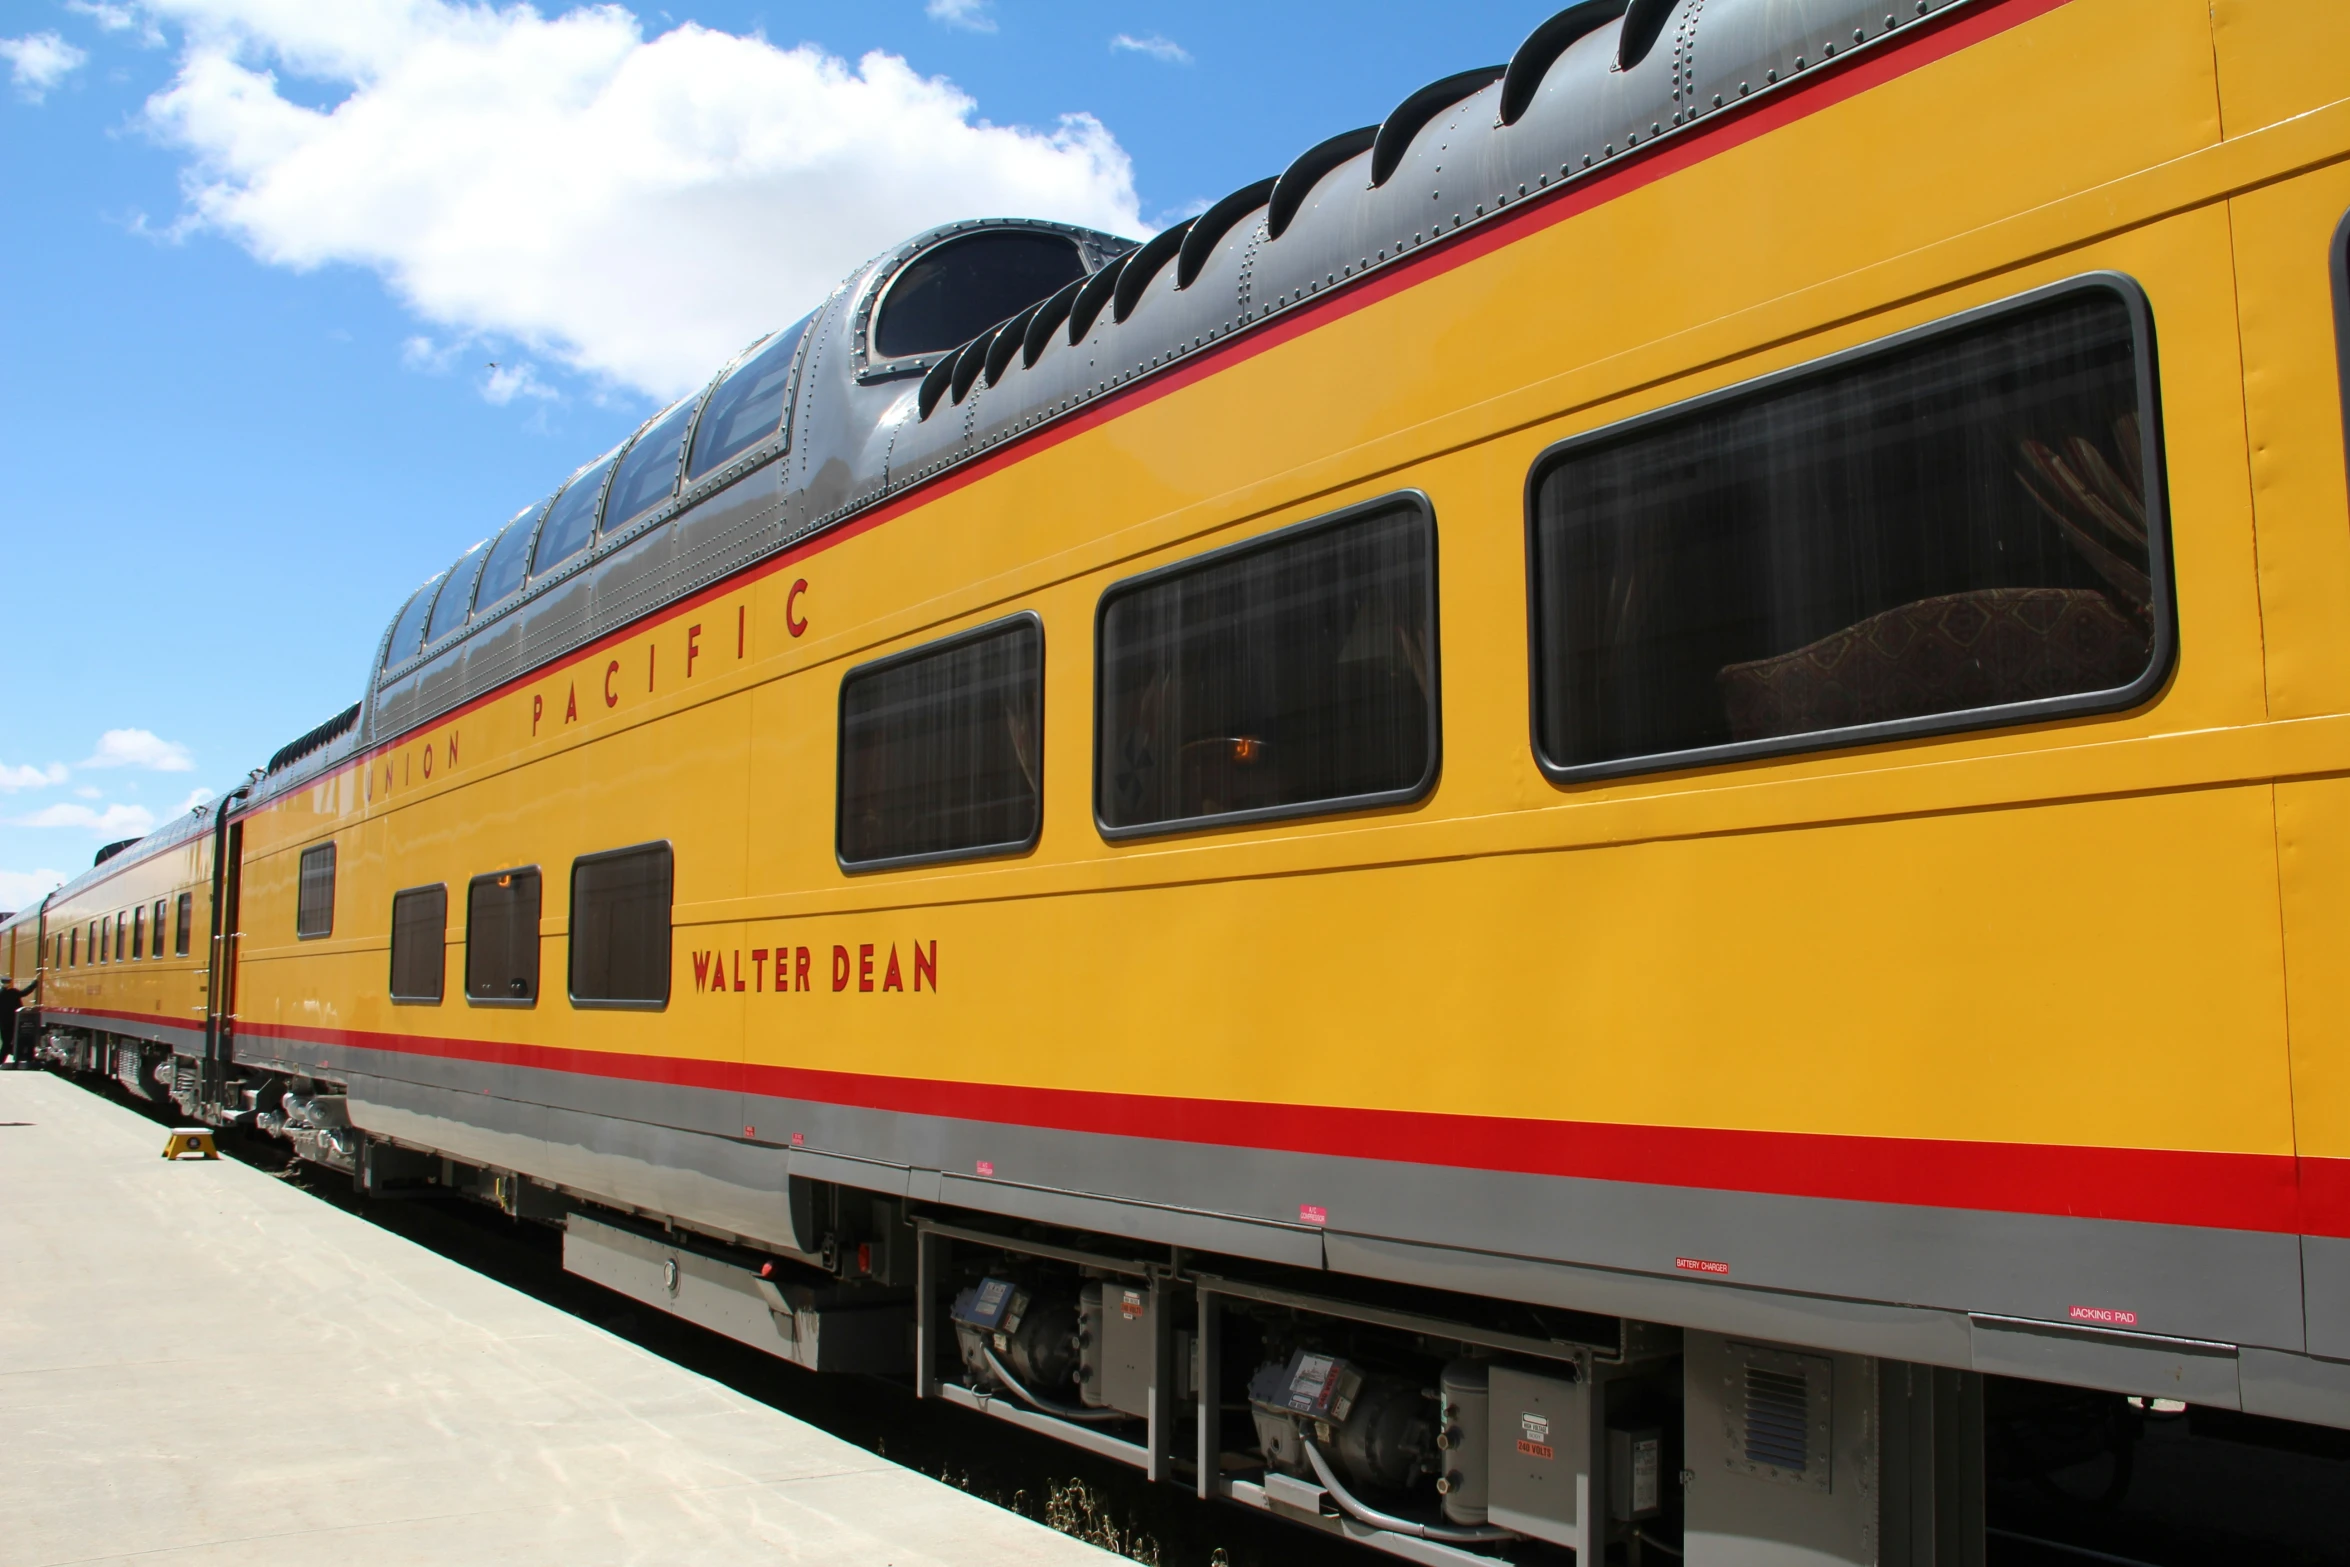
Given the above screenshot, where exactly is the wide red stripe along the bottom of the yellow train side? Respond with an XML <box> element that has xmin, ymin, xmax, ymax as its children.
<box><xmin>240</xmin><ymin>1024</ymin><xmax>2312</xmax><ymax>1236</ymax></box>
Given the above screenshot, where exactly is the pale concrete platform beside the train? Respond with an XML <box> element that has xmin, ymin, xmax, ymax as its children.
<box><xmin>0</xmin><ymin>1071</ymin><xmax>1112</xmax><ymax>1567</ymax></box>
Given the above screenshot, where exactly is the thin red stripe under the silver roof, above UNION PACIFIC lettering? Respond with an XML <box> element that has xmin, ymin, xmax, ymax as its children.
<box><xmin>289</xmin><ymin>0</ymin><xmax>2068</xmax><ymax>798</ymax></box>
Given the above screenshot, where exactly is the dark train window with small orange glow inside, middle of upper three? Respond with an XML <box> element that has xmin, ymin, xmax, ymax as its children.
<box><xmin>1093</xmin><ymin>496</ymin><xmax>1438</xmax><ymax>836</ymax></box>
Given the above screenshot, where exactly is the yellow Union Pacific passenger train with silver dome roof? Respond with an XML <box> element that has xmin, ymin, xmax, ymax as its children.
<box><xmin>18</xmin><ymin>0</ymin><xmax>2350</xmax><ymax>1565</ymax></box>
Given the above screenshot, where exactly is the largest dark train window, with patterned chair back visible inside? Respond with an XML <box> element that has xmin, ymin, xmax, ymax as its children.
<box><xmin>1528</xmin><ymin>280</ymin><xmax>2171</xmax><ymax>778</ymax></box>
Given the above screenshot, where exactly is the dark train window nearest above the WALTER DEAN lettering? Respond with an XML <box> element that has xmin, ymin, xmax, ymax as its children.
<box><xmin>834</xmin><ymin>616</ymin><xmax>1043</xmax><ymax>869</ymax></box>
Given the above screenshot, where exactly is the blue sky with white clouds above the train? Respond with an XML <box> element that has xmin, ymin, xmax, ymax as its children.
<box><xmin>0</xmin><ymin>0</ymin><xmax>1558</xmax><ymax>909</ymax></box>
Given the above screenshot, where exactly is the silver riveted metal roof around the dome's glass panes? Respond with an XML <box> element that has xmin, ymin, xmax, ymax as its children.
<box><xmin>220</xmin><ymin>0</ymin><xmax>1981</xmax><ymax>822</ymax></box>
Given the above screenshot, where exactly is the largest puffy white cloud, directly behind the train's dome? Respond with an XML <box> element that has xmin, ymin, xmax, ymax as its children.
<box><xmin>146</xmin><ymin>0</ymin><xmax>1140</xmax><ymax>397</ymax></box>
